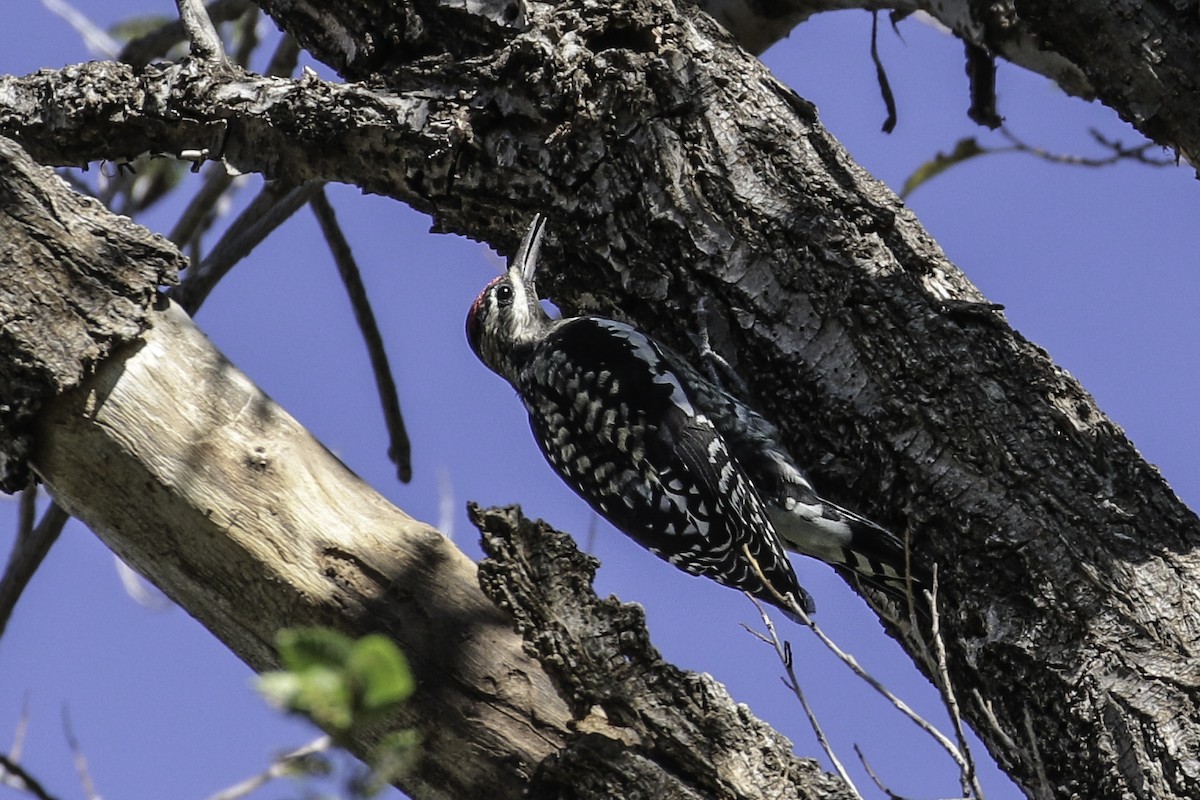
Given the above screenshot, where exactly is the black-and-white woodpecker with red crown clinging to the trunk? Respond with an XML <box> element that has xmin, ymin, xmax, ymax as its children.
<box><xmin>467</xmin><ymin>216</ymin><xmax>906</xmax><ymax>621</ymax></box>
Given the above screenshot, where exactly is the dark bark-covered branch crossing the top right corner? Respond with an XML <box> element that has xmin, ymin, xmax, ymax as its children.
<box><xmin>696</xmin><ymin>0</ymin><xmax>1200</xmax><ymax>164</ymax></box>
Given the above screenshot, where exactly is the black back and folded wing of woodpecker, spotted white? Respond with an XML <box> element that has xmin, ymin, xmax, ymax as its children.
<box><xmin>514</xmin><ymin>317</ymin><xmax>812</xmax><ymax>610</ymax></box>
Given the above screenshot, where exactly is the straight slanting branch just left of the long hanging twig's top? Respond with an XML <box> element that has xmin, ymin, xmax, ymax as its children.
<box><xmin>169</xmin><ymin>181</ymin><xmax>322</xmax><ymax>314</ymax></box>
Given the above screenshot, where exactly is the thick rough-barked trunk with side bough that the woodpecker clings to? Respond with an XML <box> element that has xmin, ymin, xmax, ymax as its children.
<box><xmin>0</xmin><ymin>0</ymin><xmax>1200</xmax><ymax>798</ymax></box>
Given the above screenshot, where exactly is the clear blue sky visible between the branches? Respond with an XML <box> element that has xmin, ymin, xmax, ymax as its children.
<box><xmin>0</xmin><ymin>0</ymin><xmax>1200</xmax><ymax>800</ymax></box>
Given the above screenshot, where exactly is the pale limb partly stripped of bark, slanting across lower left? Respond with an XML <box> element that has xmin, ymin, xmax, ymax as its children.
<box><xmin>0</xmin><ymin>139</ymin><xmax>864</xmax><ymax>800</ymax></box>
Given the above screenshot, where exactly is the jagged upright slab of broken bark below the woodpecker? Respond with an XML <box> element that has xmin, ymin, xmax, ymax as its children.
<box><xmin>469</xmin><ymin>505</ymin><xmax>852</xmax><ymax>799</ymax></box>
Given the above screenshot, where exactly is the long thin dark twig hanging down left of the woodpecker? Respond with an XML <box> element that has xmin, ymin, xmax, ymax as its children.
<box><xmin>308</xmin><ymin>188</ymin><xmax>413</xmax><ymax>483</ymax></box>
